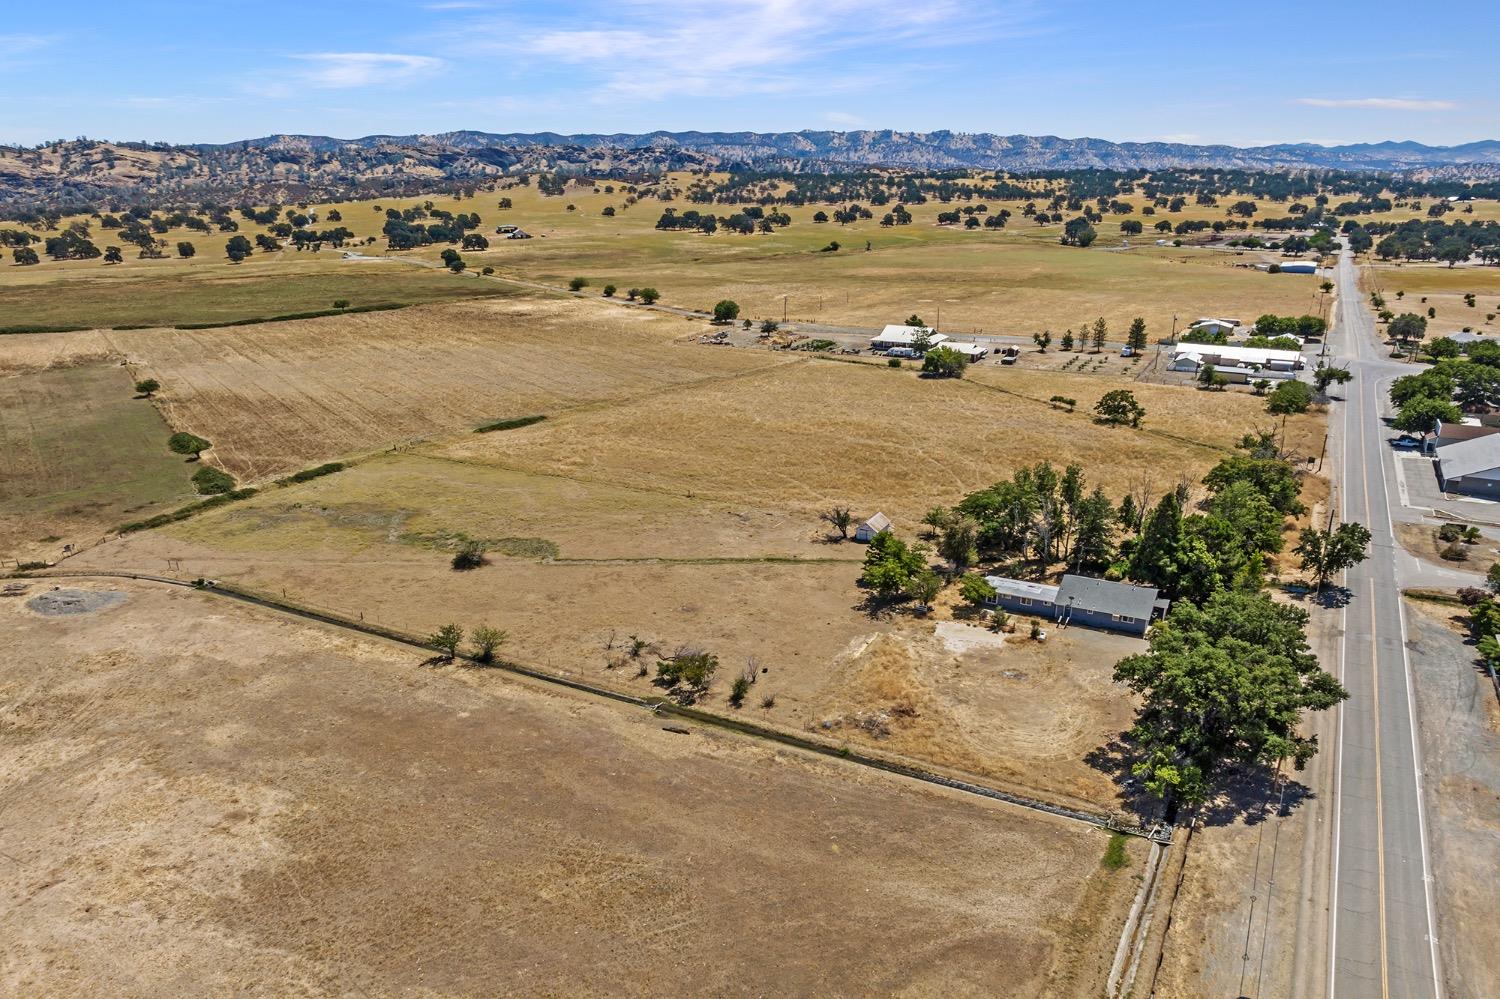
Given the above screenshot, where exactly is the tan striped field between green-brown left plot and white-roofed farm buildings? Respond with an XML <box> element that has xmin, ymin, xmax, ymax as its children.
<box><xmin>108</xmin><ymin>299</ymin><xmax>777</xmax><ymax>480</ymax></box>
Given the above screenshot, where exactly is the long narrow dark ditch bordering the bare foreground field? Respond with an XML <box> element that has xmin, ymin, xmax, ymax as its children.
<box><xmin>9</xmin><ymin>570</ymin><xmax>1172</xmax><ymax>843</ymax></box>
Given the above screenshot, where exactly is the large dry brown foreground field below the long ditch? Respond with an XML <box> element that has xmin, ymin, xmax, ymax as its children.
<box><xmin>0</xmin><ymin>582</ymin><xmax>1143</xmax><ymax>996</ymax></box>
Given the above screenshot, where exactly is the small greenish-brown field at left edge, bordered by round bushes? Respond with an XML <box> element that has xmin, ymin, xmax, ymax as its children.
<box><xmin>0</xmin><ymin>354</ymin><xmax>195</xmax><ymax>561</ymax></box>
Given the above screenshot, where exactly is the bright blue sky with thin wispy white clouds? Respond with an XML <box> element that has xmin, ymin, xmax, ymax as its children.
<box><xmin>0</xmin><ymin>0</ymin><xmax>1500</xmax><ymax>146</ymax></box>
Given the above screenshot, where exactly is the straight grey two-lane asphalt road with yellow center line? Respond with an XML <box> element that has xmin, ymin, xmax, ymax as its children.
<box><xmin>1329</xmin><ymin>254</ymin><xmax>1442</xmax><ymax>999</ymax></box>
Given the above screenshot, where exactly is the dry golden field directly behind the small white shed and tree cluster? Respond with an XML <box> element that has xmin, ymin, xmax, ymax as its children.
<box><xmin>429</xmin><ymin>349</ymin><xmax>1290</xmax><ymax>528</ymax></box>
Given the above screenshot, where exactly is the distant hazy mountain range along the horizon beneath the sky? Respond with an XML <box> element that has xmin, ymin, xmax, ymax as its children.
<box><xmin>0</xmin><ymin>131</ymin><xmax>1500</xmax><ymax>215</ymax></box>
